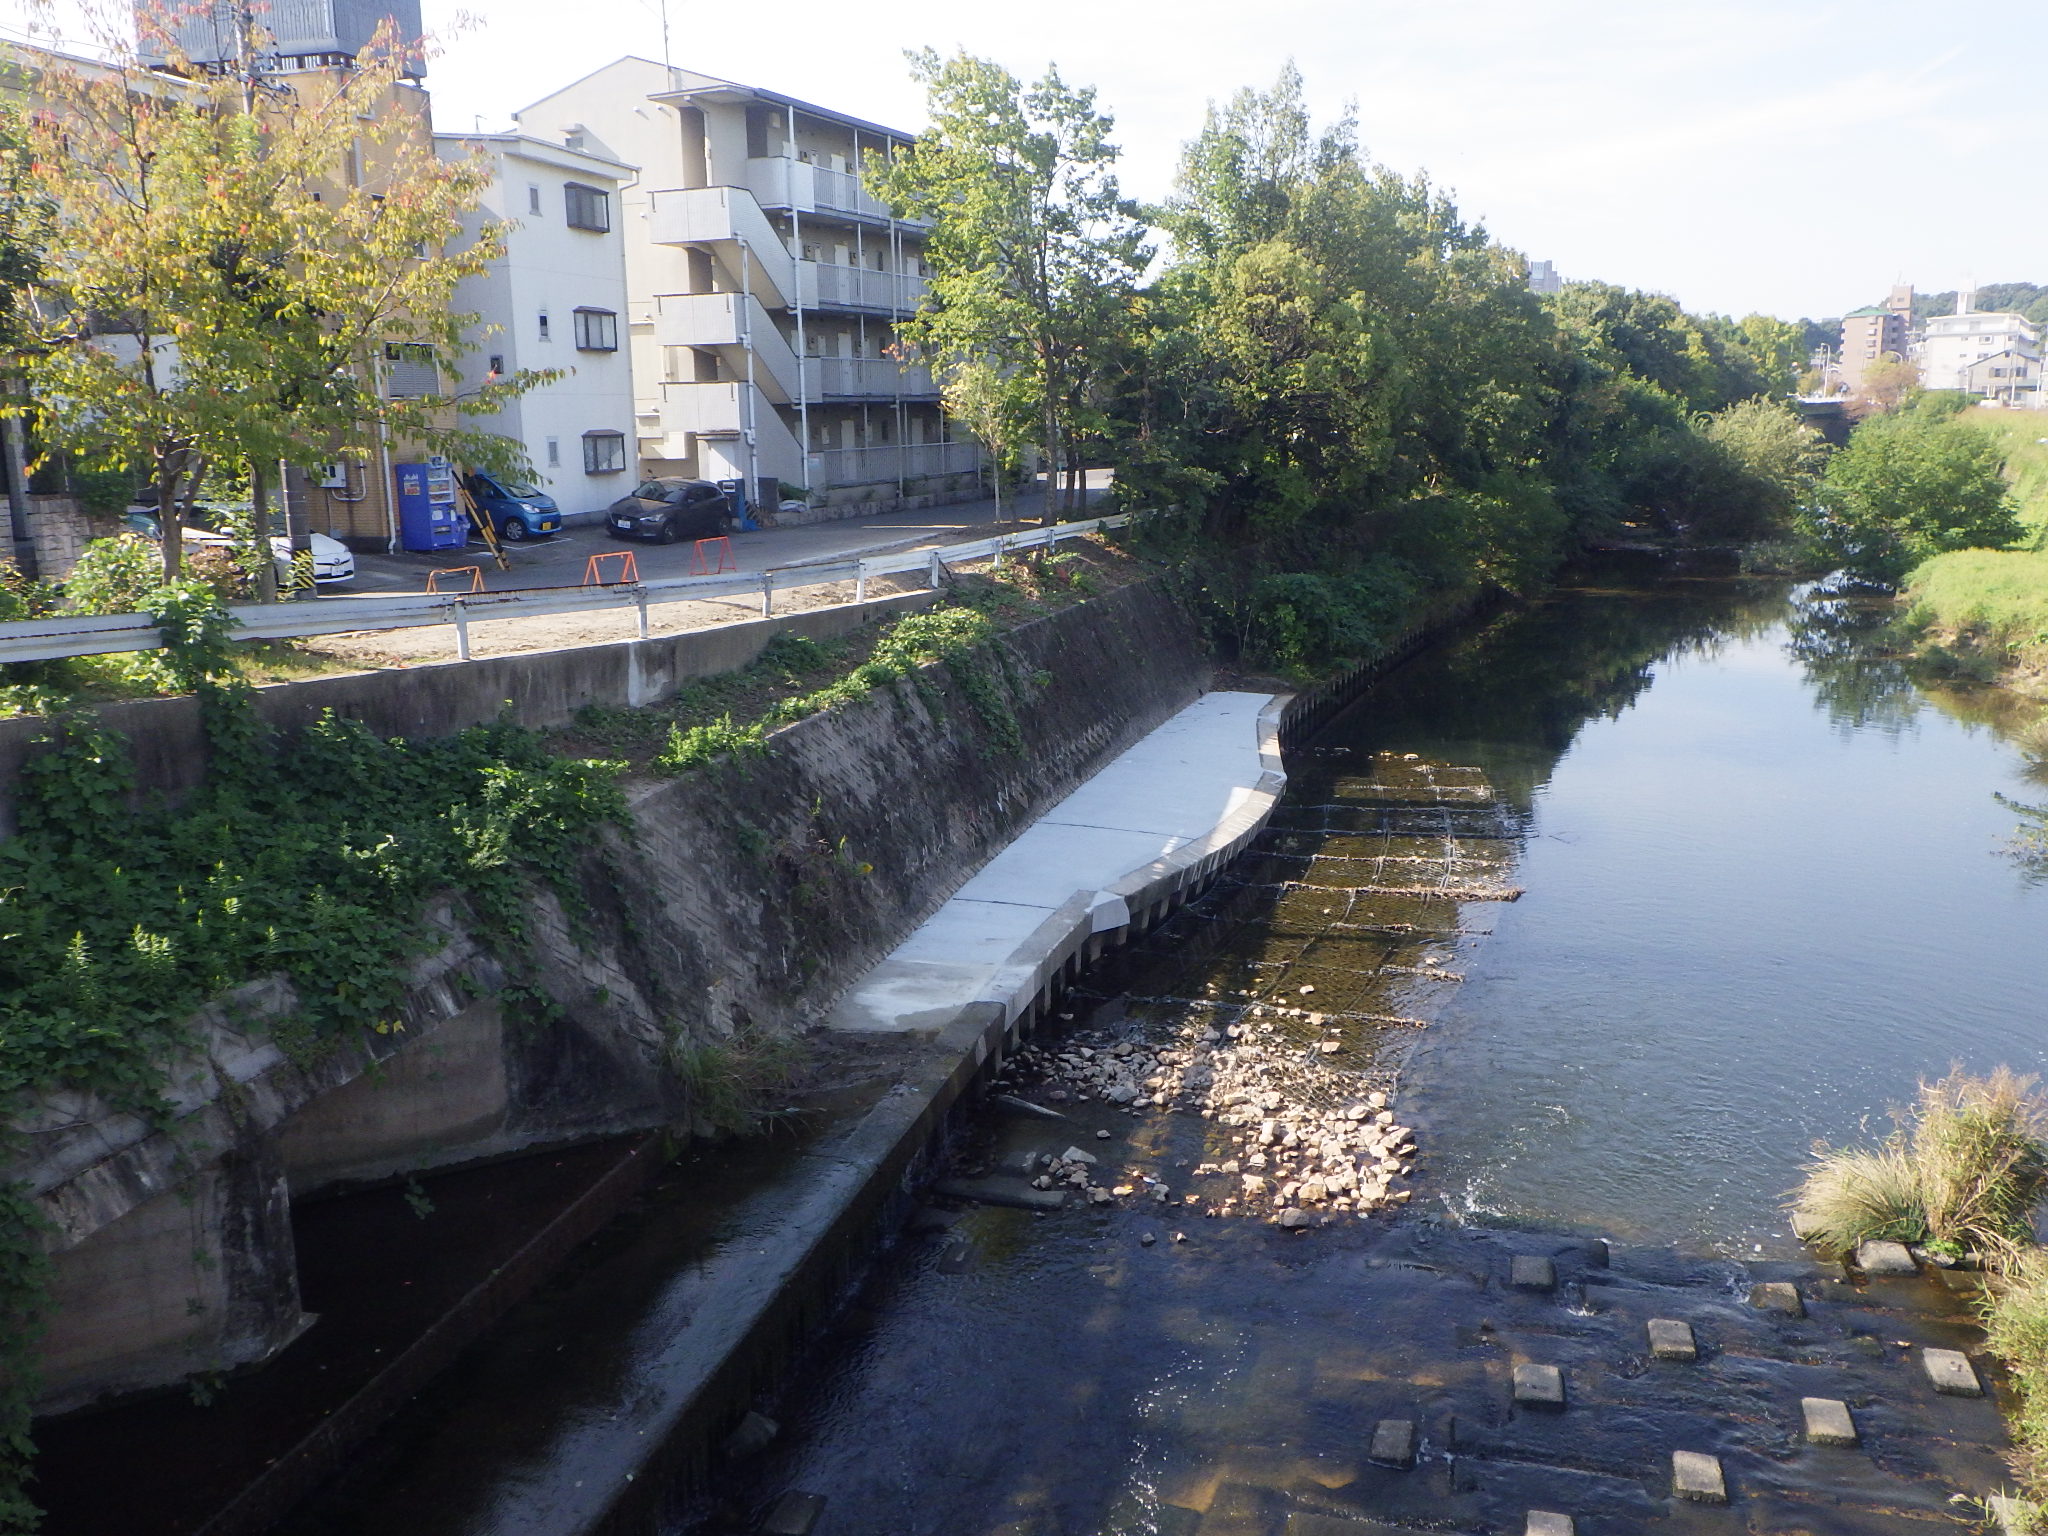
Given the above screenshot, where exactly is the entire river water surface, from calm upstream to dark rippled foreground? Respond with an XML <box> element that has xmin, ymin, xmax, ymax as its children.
<box><xmin>692</xmin><ymin>567</ymin><xmax>2048</xmax><ymax>1536</ymax></box>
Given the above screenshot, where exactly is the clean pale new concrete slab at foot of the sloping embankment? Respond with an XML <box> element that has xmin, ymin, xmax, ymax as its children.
<box><xmin>831</xmin><ymin>692</ymin><xmax>1284</xmax><ymax>1032</ymax></box>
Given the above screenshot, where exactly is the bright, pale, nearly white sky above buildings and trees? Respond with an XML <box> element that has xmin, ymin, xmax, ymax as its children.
<box><xmin>16</xmin><ymin>0</ymin><xmax>2048</xmax><ymax>319</ymax></box>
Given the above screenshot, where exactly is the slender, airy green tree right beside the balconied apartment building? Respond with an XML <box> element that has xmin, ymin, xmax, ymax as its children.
<box><xmin>872</xmin><ymin>49</ymin><xmax>1151</xmax><ymax>522</ymax></box>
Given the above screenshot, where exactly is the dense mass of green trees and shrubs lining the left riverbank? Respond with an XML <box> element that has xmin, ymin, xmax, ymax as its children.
<box><xmin>877</xmin><ymin>64</ymin><xmax>1806</xmax><ymax>672</ymax></box>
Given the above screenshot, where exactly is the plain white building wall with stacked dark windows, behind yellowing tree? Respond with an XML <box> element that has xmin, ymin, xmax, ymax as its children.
<box><xmin>434</xmin><ymin>133</ymin><xmax>639</xmax><ymax>522</ymax></box>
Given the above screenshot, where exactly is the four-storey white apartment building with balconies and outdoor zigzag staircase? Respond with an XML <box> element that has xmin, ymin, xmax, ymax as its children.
<box><xmin>516</xmin><ymin>57</ymin><xmax>981</xmax><ymax>518</ymax></box>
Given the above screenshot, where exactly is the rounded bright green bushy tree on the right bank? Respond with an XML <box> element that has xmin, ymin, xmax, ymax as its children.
<box><xmin>1810</xmin><ymin>412</ymin><xmax>2021</xmax><ymax>586</ymax></box>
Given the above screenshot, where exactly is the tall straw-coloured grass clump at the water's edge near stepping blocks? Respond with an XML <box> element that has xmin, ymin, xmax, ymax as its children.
<box><xmin>1792</xmin><ymin>1067</ymin><xmax>2048</xmax><ymax>1268</ymax></box>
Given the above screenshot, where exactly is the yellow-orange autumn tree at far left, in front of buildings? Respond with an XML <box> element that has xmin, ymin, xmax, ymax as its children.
<box><xmin>12</xmin><ymin>10</ymin><xmax>537</xmax><ymax>580</ymax></box>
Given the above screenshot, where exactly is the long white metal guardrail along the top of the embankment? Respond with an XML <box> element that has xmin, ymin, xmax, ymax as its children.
<box><xmin>0</xmin><ymin>514</ymin><xmax>1130</xmax><ymax>662</ymax></box>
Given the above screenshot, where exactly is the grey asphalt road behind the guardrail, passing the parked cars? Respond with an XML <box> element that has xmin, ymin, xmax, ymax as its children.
<box><xmin>330</xmin><ymin>475</ymin><xmax>1100</xmax><ymax>596</ymax></box>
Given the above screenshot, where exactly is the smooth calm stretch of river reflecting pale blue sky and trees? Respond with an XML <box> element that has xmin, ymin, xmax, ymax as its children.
<box><xmin>1343</xmin><ymin>561</ymin><xmax>2048</xmax><ymax>1253</ymax></box>
